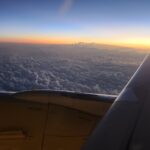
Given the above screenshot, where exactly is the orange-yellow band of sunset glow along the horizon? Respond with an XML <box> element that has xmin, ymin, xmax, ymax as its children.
<box><xmin>0</xmin><ymin>36</ymin><xmax>150</xmax><ymax>49</ymax></box>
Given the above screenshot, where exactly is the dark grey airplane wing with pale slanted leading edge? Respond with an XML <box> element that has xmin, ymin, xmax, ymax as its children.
<box><xmin>82</xmin><ymin>55</ymin><xmax>150</xmax><ymax>150</ymax></box>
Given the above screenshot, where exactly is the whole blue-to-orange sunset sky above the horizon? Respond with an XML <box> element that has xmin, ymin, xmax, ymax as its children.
<box><xmin>0</xmin><ymin>0</ymin><xmax>150</xmax><ymax>48</ymax></box>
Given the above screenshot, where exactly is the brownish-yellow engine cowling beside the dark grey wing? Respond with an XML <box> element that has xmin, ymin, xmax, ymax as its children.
<box><xmin>0</xmin><ymin>90</ymin><xmax>117</xmax><ymax>150</ymax></box>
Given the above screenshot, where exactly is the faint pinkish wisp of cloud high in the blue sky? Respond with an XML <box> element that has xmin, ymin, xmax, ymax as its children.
<box><xmin>60</xmin><ymin>0</ymin><xmax>74</xmax><ymax>15</ymax></box>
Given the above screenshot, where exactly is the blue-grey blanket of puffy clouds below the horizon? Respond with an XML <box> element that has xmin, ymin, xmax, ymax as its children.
<box><xmin>0</xmin><ymin>44</ymin><xmax>144</xmax><ymax>94</ymax></box>
